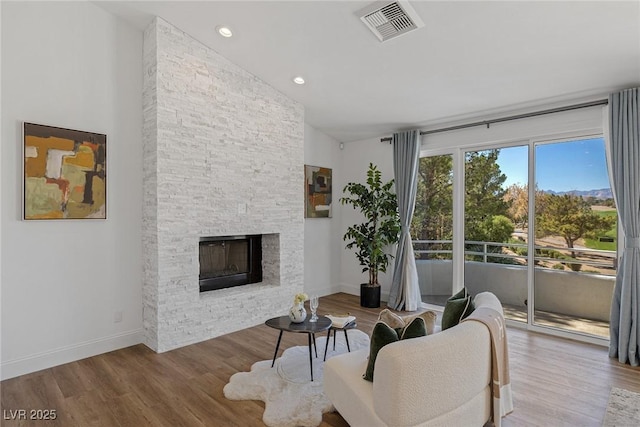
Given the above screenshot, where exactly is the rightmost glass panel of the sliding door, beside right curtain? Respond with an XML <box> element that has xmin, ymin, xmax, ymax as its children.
<box><xmin>533</xmin><ymin>138</ymin><xmax>617</xmax><ymax>338</ymax></box>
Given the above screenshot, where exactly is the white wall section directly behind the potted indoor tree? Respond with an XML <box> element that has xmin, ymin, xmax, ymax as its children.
<box><xmin>334</xmin><ymin>135</ymin><xmax>393</xmax><ymax>301</ymax></box>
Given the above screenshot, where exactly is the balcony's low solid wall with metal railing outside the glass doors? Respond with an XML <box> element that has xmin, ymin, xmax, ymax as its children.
<box><xmin>413</xmin><ymin>240</ymin><xmax>616</xmax><ymax>336</ymax></box>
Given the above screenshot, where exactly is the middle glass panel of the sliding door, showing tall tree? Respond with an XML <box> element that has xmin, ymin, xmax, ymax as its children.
<box><xmin>464</xmin><ymin>145</ymin><xmax>529</xmax><ymax>322</ymax></box>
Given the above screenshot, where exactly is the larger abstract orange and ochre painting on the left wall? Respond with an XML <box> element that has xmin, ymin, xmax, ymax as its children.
<box><xmin>22</xmin><ymin>122</ymin><xmax>107</xmax><ymax>220</ymax></box>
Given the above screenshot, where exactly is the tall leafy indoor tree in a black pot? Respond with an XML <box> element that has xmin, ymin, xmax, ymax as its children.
<box><xmin>340</xmin><ymin>163</ymin><xmax>400</xmax><ymax>308</ymax></box>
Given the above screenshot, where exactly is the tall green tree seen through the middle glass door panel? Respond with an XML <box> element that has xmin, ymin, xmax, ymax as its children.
<box><xmin>464</xmin><ymin>149</ymin><xmax>508</xmax><ymax>242</ymax></box>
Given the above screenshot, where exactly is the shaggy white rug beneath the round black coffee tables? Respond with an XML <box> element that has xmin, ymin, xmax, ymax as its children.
<box><xmin>224</xmin><ymin>329</ymin><xmax>369</xmax><ymax>427</ymax></box>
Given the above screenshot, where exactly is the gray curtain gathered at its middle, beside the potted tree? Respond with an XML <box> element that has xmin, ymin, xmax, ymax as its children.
<box><xmin>387</xmin><ymin>130</ymin><xmax>422</xmax><ymax>311</ymax></box>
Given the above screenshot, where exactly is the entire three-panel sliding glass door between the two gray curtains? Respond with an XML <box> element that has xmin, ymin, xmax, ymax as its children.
<box><xmin>412</xmin><ymin>137</ymin><xmax>617</xmax><ymax>339</ymax></box>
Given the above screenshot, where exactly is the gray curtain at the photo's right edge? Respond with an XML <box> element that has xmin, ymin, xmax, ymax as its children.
<box><xmin>606</xmin><ymin>88</ymin><xmax>640</xmax><ymax>366</ymax></box>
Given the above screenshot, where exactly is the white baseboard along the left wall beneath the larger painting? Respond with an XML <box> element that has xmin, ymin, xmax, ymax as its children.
<box><xmin>0</xmin><ymin>329</ymin><xmax>143</xmax><ymax>380</ymax></box>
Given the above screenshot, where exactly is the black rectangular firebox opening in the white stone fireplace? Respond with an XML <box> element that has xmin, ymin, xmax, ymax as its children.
<box><xmin>200</xmin><ymin>235</ymin><xmax>262</xmax><ymax>292</ymax></box>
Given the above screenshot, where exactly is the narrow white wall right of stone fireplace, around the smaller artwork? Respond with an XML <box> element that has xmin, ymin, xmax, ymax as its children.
<box><xmin>304</xmin><ymin>124</ymin><xmax>344</xmax><ymax>295</ymax></box>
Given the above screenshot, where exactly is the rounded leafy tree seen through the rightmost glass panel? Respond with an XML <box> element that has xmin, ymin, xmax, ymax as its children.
<box><xmin>536</xmin><ymin>194</ymin><xmax>616</xmax><ymax>248</ymax></box>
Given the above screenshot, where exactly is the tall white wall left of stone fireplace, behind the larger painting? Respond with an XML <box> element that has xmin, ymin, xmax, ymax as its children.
<box><xmin>0</xmin><ymin>2</ymin><xmax>142</xmax><ymax>379</ymax></box>
